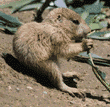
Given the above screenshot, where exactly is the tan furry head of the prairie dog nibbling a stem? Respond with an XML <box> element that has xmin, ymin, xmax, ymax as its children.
<box><xmin>43</xmin><ymin>8</ymin><xmax>91</xmax><ymax>40</ymax></box>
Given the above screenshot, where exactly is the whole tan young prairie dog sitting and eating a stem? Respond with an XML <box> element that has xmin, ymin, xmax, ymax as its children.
<box><xmin>13</xmin><ymin>8</ymin><xmax>93</xmax><ymax>96</ymax></box>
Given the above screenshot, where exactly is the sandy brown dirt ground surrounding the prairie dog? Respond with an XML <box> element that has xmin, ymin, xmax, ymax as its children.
<box><xmin>0</xmin><ymin>0</ymin><xmax>110</xmax><ymax>107</ymax></box>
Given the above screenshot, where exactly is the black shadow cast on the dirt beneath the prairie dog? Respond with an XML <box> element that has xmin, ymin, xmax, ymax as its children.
<box><xmin>2</xmin><ymin>53</ymin><xmax>110</xmax><ymax>104</ymax></box>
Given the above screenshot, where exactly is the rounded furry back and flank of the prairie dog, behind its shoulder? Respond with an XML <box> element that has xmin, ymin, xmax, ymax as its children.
<box><xmin>13</xmin><ymin>22</ymin><xmax>55</xmax><ymax>64</ymax></box>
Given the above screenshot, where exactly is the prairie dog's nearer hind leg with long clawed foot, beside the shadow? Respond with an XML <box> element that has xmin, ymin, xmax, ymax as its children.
<box><xmin>38</xmin><ymin>60</ymin><xmax>84</xmax><ymax>97</ymax></box>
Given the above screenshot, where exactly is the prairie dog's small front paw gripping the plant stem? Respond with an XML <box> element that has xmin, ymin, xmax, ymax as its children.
<box><xmin>82</xmin><ymin>39</ymin><xmax>93</xmax><ymax>51</ymax></box>
